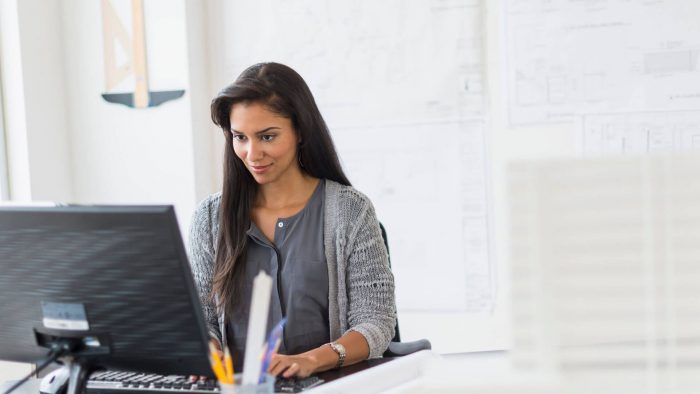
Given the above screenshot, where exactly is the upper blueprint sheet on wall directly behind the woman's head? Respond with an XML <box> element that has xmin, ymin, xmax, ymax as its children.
<box><xmin>224</xmin><ymin>0</ymin><xmax>483</xmax><ymax>126</ymax></box>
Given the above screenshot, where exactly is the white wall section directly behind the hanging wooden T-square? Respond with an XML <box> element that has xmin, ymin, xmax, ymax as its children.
<box><xmin>62</xmin><ymin>1</ymin><xmax>209</xmax><ymax>229</ymax></box>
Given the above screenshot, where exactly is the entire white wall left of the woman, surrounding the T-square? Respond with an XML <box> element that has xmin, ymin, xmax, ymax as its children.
<box><xmin>0</xmin><ymin>0</ymin><xmax>219</xmax><ymax>380</ymax></box>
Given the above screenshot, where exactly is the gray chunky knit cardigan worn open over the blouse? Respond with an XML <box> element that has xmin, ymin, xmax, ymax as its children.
<box><xmin>188</xmin><ymin>180</ymin><xmax>396</xmax><ymax>358</ymax></box>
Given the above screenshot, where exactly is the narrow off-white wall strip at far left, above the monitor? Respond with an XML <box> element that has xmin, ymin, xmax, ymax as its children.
<box><xmin>1</xmin><ymin>0</ymin><xmax>72</xmax><ymax>201</ymax></box>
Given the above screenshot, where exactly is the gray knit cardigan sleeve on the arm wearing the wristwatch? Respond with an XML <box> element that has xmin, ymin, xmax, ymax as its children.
<box><xmin>346</xmin><ymin>199</ymin><xmax>396</xmax><ymax>358</ymax></box>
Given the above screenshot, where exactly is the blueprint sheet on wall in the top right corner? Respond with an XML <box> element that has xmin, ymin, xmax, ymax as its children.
<box><xmin>504</xmin><ymin>0</ymin><xmax>700</xmax><ymax>125</ymax></box>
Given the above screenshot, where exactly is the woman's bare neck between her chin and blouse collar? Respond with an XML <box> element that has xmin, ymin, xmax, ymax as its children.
<box><xmin>255</xmin><ymin>172</ymin><xmax>319</xmax><ymax>210</ymax></box>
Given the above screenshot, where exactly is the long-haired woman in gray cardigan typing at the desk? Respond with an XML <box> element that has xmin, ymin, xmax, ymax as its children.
<box><xmin>190</xmin><ymin>63</ymin><xmax>396</xmax><ymax>377</ymax></box>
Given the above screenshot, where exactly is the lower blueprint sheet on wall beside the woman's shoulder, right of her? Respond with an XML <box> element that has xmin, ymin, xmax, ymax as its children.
<box><xmin>335</xmin><ymin>121</ymin><xmax>495</xmax><ymax>312</ymax></box>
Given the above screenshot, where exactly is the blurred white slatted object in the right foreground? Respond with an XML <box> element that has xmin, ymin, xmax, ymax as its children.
<box><xmin>509</xmin><ymin>155</ymin><xmax>700</xmax><ymax>394</ymax></box>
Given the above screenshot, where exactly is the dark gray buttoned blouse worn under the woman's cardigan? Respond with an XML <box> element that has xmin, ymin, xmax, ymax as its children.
<box><xmin>226</xmin><ymin>180</ymin><xmax>330</xmax><ymax>367</ymax></box>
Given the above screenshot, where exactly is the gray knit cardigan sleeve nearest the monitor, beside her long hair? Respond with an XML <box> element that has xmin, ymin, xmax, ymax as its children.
<box><xmin>187</xmin><ymin>197</ymin><xmax>221</xmax><ymax>344</ymax></box>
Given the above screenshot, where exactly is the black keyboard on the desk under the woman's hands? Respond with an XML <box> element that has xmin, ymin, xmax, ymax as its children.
<box><xmin>86</xmin><ymin>371</ymin><xmax>324</xmax><ymax>394</ymax></box>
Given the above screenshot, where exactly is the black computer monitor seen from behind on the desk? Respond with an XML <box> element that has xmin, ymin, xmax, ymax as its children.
<box><xmin>0</xmin><ymin>206</ymin><xmax>212</xmax><ymax>394</ymax></box>
